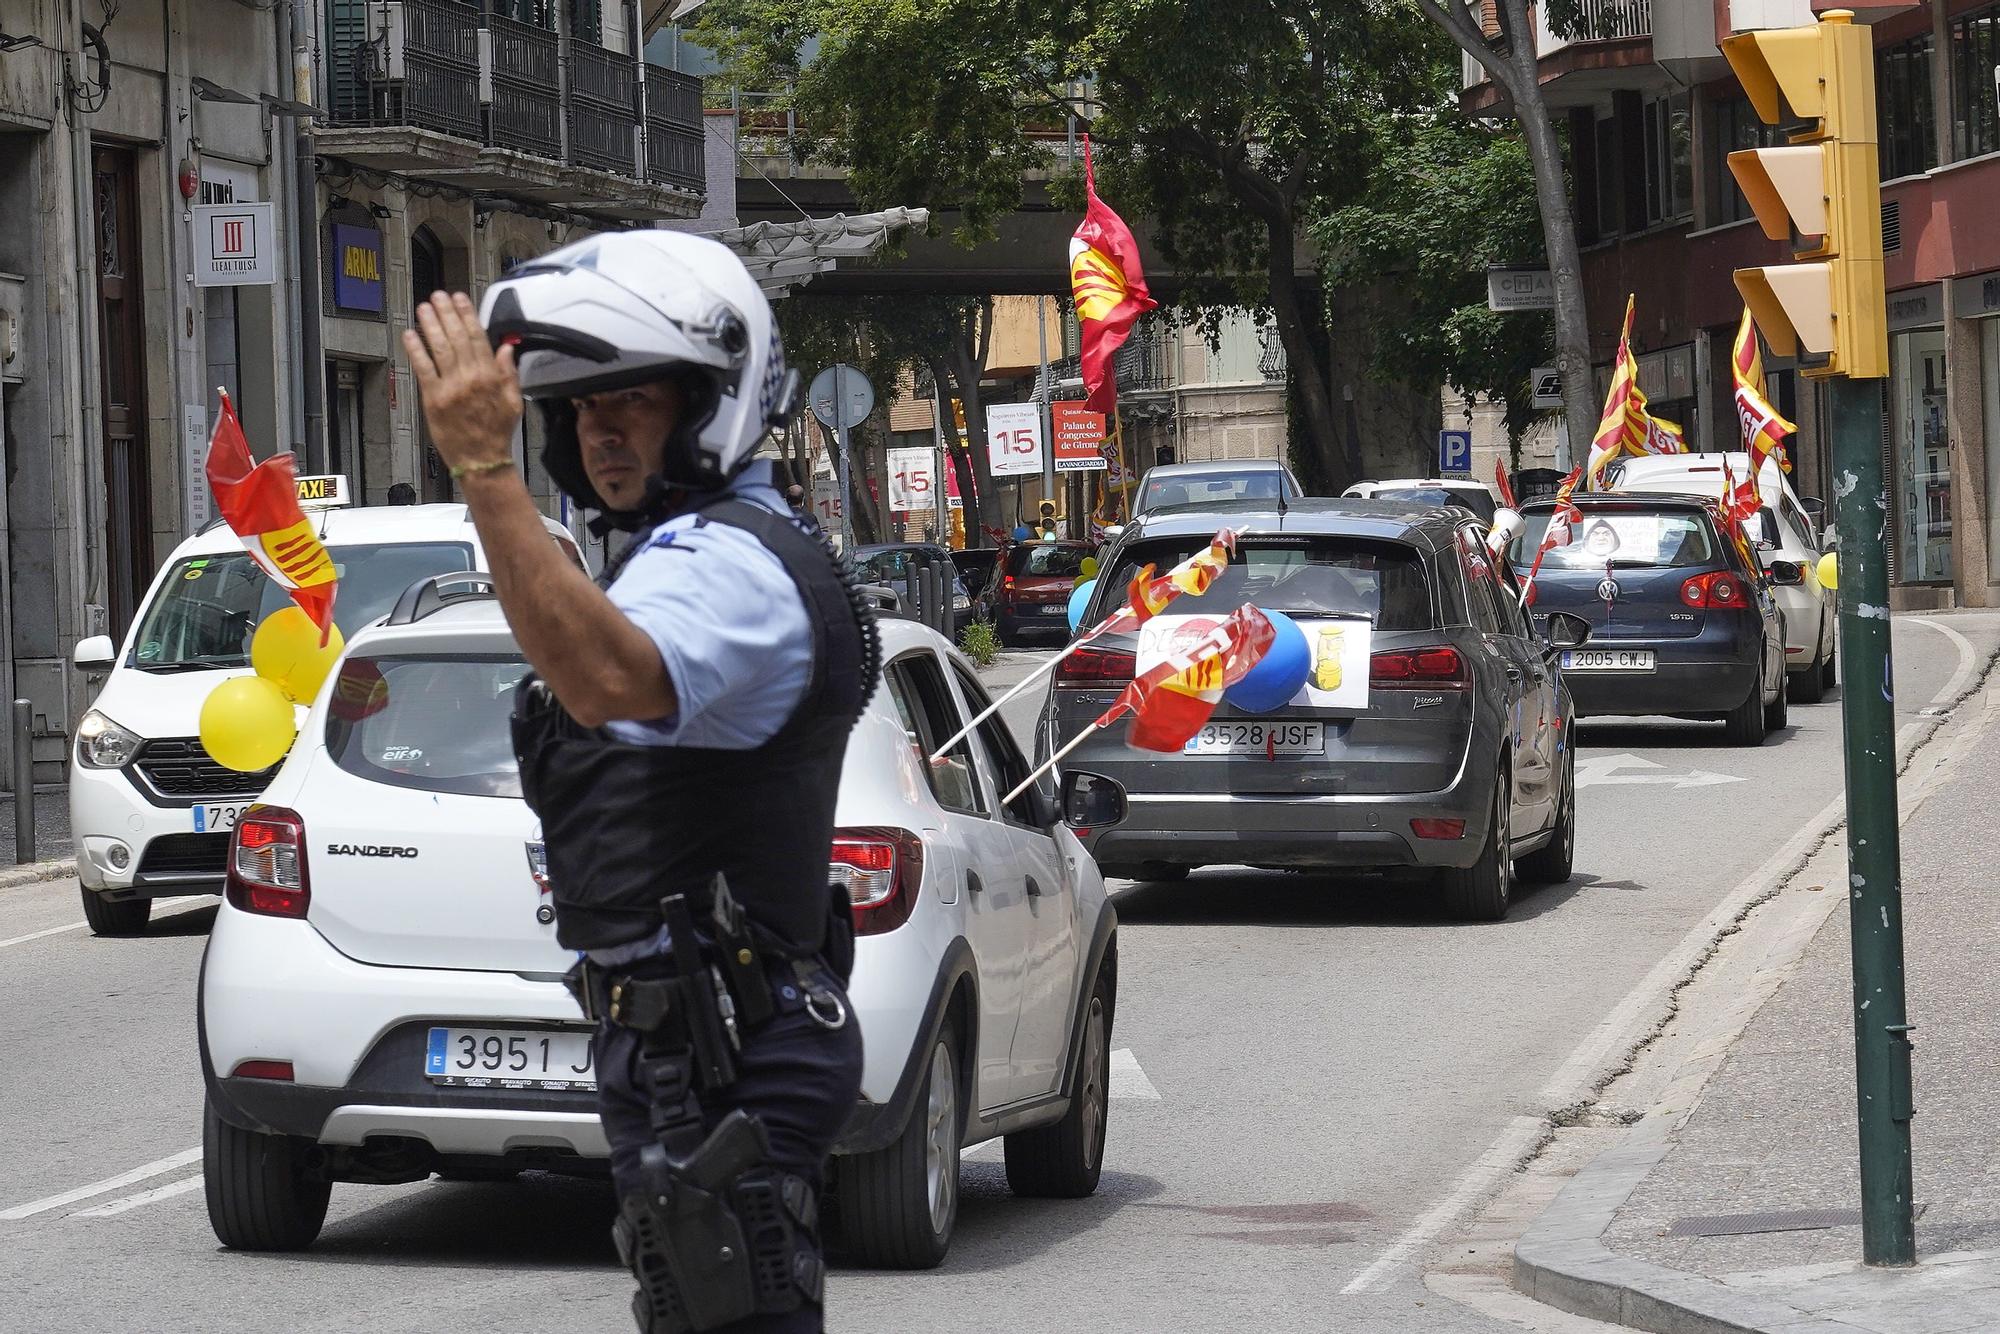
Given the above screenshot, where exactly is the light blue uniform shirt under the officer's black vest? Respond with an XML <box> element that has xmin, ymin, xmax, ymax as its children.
<box><xmin>606</xmin><ymin>462</ymin><xmax>812</xmax><ymax>750</ymax></box>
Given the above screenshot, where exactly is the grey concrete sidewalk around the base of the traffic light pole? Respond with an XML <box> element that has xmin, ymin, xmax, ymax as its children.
<box><xmin>1514</xmin><ymin>652</ymin><xmax>2000</xmax><ymax>1334</ymax></box>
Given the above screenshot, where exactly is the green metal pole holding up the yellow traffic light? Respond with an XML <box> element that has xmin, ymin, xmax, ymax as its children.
<box><xmin>1826</xmin><ymin>376</ymin><xmax>1916</xmax><ymax>1264</ymax></box>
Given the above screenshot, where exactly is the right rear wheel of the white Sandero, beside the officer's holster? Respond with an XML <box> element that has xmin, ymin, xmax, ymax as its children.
<box><xmin>832</xmin><ymin>1022</ymin><xmax>966</xmax><ymax>1270</ymax></box>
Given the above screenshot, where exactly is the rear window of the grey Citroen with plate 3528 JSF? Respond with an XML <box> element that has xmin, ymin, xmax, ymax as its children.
<box><xmin>1094</xmin><ymin>538</ymin><xmax>1436</xmax><ymax>630</ymax></box>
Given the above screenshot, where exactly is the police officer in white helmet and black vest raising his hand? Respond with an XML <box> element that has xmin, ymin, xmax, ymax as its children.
<box><xmin>404</xmin><ymin>232</ymin><xmax>880</xmax><ymax>1334</ymax></box>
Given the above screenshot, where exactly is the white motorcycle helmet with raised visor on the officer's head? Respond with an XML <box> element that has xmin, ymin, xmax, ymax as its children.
<box><xmin>480</xmin><ymin>230</ymin><xmax>800</xmax><ymax>528</ymax></box>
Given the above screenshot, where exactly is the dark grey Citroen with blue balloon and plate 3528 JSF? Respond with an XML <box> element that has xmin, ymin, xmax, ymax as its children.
<box><xmin>1038</xmin><ymin>498</ymin><xmax>1588</xmax><ymax>920</ymax></box>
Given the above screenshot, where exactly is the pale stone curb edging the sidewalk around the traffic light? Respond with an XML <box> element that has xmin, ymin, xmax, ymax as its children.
<box><xmin>1512</xmin><ymin>656</ymin><xmax>2000</xmax><ymax>1334</ymax></box>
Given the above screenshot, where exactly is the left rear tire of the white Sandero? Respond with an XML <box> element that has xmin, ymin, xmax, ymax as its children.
<box><xmin>202</xmin><ymin>1104</ymin><xmax>334</xmax><ymax>1250</ymax></box>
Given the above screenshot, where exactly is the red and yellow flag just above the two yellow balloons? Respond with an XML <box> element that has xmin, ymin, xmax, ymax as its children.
<box><xmin>208</xmin><ymin>390</ymin><xmax>338</xmax><ymax>648</ymax></box>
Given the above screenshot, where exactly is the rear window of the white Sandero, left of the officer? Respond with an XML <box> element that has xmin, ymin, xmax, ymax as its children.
<box><xmin>326</xmin><ymin>656</ymin><xmax>528</xmax><ymax>796</ymax></box>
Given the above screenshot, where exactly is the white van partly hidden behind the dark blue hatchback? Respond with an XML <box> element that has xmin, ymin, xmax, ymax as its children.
<box><xmin>1604</xmin><ymin>450</ymin><xmax>1838</xmax><ymax>704</ymax></box>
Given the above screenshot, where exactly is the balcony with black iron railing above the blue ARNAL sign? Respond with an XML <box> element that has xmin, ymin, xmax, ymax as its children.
<box><xmin>316</xmin><ymin>0</ymin><xmax>706</xmax><ymax>218</ymax></box>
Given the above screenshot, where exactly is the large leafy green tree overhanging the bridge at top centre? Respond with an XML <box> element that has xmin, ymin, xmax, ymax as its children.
<box><xmin>698</xmin><ymin>0</ymin><xmax>1456</xmax><ymax>482</ymax></box>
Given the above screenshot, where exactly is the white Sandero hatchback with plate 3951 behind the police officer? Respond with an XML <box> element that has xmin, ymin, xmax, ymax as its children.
<box><xmin>198</xmin><ymin>576</ymin><xmax>1124</xmax><ymax>1266</ymax></box>
